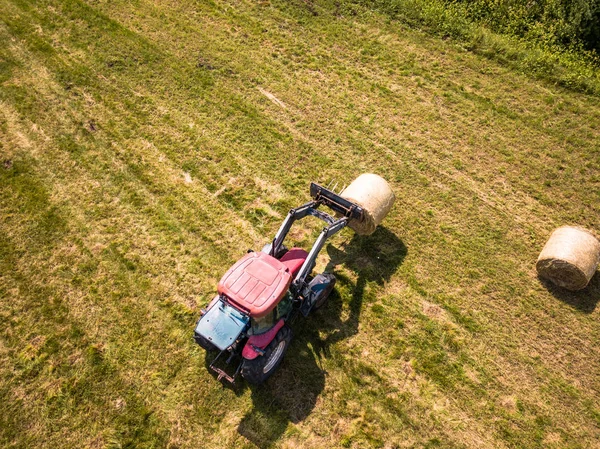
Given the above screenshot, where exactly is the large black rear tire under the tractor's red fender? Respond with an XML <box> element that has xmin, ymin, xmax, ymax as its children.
<box><xmin>241</xmin><ymin>325</ymin><xmax>292</xmax><ymax>384</ymax></box>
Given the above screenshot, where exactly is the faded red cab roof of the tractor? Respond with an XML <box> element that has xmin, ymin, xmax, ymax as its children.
<box><xmin>218</xmin><ymin>252</ymin><xmax>292</xmax><ymax>318</ymax></box>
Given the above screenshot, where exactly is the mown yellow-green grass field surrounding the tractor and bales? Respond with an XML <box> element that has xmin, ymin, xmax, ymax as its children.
<box><xmin>0</xmin><ymin>0</ymin><xmax>600</xmax><ymax>449</ymax></box>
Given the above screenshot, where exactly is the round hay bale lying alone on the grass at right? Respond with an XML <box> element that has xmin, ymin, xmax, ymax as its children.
<box><xmin>536</xmin><ymin>226</ymin><xmax>600</xmax><ymax>290</ymax></box>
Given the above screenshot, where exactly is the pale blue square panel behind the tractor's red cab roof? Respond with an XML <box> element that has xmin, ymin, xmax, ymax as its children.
<box><xmin>195</xmin><ymin>300</ymin><xmax>250</xmax><ymax>351</ymax></box>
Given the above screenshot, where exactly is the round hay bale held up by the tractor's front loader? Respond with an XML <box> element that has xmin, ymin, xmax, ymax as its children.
<box><xmin>340</xmin><ymin>173</ymin><xmax>396</xmax><ymax>235</ymax></box>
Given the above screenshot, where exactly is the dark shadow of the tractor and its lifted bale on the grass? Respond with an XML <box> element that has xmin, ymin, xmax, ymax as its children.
<box><xmin>238</xmin><ymin>226</ymin><xmax>407</xmax><ymax>448</ymax></box>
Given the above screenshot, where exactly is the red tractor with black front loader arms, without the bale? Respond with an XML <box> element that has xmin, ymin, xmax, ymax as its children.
<box><xmin>194</xmin><ymin>175</ymin><xmax>393</xmax><ymax>384</ymax></box>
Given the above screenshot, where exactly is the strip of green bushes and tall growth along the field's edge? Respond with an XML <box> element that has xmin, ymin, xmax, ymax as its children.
<box><xmin>347</xmin><ymin>0</ymin><xmax>600</xmax><ymax>95</ymax></box>
